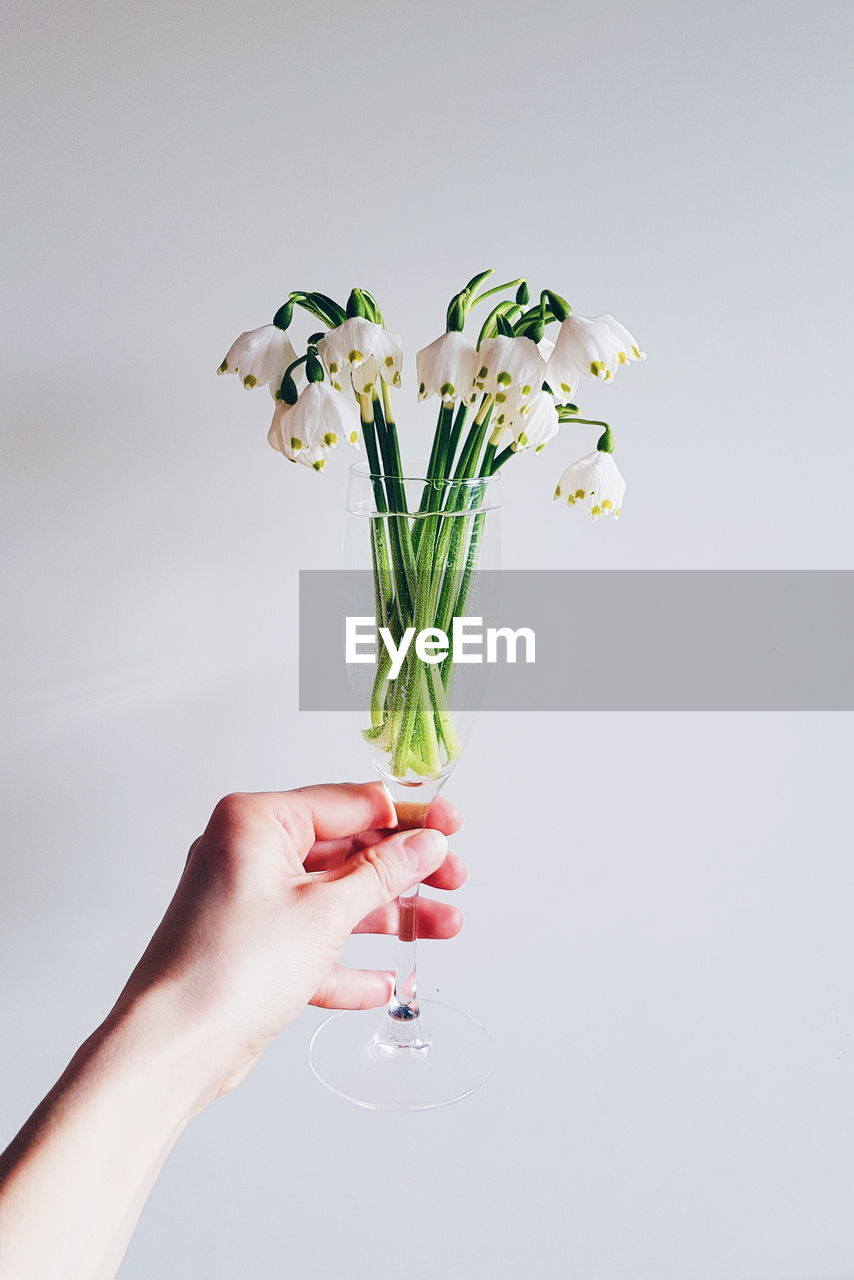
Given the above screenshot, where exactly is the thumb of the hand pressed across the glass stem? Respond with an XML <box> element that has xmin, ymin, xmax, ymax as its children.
<box><xmin>323</xmin><ymin>827</ymin><xmax>448</xmax><ymax>927</ymax></box>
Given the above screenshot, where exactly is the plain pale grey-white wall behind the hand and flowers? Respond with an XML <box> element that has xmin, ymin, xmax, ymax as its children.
<box><xmin>0</xmin><ymin>0</ymin><xmax>854</xmax><ymax>1280</ymax></box>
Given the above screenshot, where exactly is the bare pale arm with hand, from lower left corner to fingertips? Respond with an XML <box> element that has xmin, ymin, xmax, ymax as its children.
<box><xmin>0</xmin><ymin>782</ymin><xmax>466</xmax><ymax>1280</ymax></box>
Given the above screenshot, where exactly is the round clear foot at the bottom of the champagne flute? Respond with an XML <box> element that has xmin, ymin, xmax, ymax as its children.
<box><xmin>309</xmin><ymin>1000</ymin><xmax>494</xmax><ymax>1111</ymax></box>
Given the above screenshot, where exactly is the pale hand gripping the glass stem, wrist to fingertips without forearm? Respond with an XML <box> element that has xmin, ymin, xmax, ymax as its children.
<box><xmin>117</xmin><ymin>782</ymin><xmax>466</xmax><ymax>1103</ymax></box>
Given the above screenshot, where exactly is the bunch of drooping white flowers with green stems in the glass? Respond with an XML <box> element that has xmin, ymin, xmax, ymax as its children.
<box><xmin>219</xmin><ymin>270</ymin><xmax>644</xmax><ymax>780</ymax></box>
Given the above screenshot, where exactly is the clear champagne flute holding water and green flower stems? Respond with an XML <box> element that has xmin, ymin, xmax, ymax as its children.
<box><xmin>310</xmin><ymin>463</ymin><xmax>499</xmax><ymax>1111</ymax></box>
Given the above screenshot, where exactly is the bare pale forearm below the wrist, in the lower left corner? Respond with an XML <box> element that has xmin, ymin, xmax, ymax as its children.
<box><xmin>0</xmin><ymin>993</ymin><xmax>217</xmax><ymax>1280</ymax></box>
